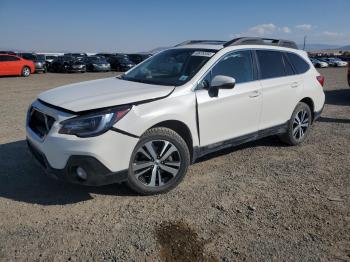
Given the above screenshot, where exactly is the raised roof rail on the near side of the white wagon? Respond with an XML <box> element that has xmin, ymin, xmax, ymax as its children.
<box><xmin>224</xmin><ymin>37</ymin><xmax>298</xmax><ymax>49</ymax></box>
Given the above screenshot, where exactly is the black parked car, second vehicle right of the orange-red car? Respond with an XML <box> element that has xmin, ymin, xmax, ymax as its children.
<box><xmin>50</xmin><ymin>56</ymin><xmax>86</xmax><ymax>73</ymax></box>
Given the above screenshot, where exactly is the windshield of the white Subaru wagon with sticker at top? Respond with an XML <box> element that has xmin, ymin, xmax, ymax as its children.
<box><xmin>122</xmin><ymin>48</ymin><xmax>216</xmax><ymax>86</ymax></box>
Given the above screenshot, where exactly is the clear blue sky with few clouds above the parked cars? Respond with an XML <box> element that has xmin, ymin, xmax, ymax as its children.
<box><xmin>0</xmin><ymin>0</ymin><xmax>350</xmax><ymax>52</ymax></box>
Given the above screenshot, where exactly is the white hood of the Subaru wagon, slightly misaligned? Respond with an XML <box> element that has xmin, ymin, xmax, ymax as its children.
<box><xmin>38</xmin><ymin>77</ymin><xmax>175</xmax><ymax>112</ymax></box>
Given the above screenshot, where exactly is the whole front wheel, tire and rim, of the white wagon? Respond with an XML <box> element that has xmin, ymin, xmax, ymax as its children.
<box><xmin>127</xmin><ymin>127</ymin><xmax>190</xmax><ymax>195</ymax></box>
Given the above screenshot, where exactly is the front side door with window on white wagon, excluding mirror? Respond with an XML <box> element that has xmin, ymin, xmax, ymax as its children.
<box><xmin>195</xmin><ymin>50</ymin><xmax>262</xmax><ymax>146</ymax></box>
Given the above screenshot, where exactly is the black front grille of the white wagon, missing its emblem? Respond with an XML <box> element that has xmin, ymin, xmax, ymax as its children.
<box><xmin>28</xmin><ymin>107</ymin><xmax>55</xmax><ymax>138</ymax></box>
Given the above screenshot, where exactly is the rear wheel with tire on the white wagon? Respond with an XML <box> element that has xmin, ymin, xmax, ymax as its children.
<box><xmin>280</xmin><ymin>102</ymin><xmax>312</xmax><ymax>146</ymax></box>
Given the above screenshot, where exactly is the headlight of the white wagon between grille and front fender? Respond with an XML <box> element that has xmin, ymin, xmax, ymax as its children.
<box><xmin>58</xmin><ymin>107</ymin><xmax>130</xmax><ymax>137</ymax></box>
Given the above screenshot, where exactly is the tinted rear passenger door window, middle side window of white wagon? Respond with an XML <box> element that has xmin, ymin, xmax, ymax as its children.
<box><xmin>256</xmin><ymin>50</ymin><xmax>286</xmax><ymax>79</ymax></box>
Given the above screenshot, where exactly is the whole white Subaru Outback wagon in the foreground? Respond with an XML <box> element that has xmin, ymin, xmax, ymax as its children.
<box><xmin>26</xmin><ymin>37</ymin><xmax>325</xmax><ymax>194</ymax></box>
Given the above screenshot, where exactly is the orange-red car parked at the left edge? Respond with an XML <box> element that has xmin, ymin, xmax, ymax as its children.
<box><xmin>0</xmin><ymin>54</ymin><xmax>35</xmax><ymax>76</ymax></box>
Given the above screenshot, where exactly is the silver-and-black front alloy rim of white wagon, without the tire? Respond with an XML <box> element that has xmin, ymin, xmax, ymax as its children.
<box><xmin>132</xmin><ymin>140</ymin><xmax>181</xmax><ymax>187</ymax></box>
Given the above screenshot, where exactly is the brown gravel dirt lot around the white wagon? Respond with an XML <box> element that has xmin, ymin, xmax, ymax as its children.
<box><xmin>0</xmin><ymin>68</ymin><xmax>350</xmax><ymax>261</ymax></box>
